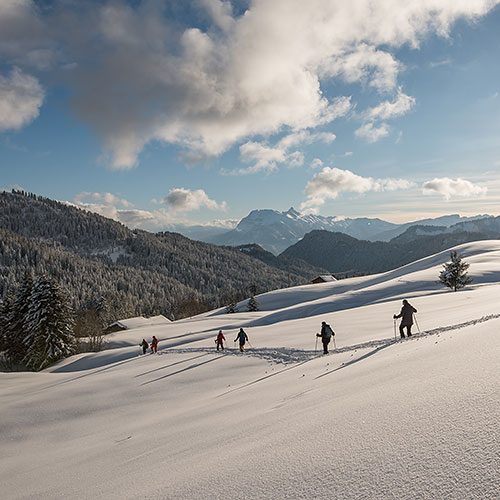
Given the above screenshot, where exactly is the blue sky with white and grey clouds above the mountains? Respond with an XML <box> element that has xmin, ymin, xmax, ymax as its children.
<box><xmin>0</xmin><ymin>0</ymin><xmax>500</xmax><ymax>231</ymax></box>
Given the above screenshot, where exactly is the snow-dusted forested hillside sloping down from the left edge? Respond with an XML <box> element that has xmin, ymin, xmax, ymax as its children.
<box><xmin>0</xmin><ymin>192</ymin><xmax>314</xmax><ymax>318</ymax></box>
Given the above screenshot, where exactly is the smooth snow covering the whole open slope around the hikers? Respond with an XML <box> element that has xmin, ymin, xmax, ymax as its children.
<box><xmin>0</xmin><ymin>240</ymin><xmax>500</xmax><ymax>500</ymax></box>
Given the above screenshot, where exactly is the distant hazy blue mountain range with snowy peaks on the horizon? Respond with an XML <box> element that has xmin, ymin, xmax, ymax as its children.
<box><xmin>200</xmin><ymin>208</ymin><xmax>490</xmax><ymax>255</ymax></box>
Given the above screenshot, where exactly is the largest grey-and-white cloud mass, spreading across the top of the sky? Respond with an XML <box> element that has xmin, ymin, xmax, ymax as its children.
<box><xmin>0</xmin><ymin>0</ymin><xmax>498</xmax><ymax>169</ymax></box>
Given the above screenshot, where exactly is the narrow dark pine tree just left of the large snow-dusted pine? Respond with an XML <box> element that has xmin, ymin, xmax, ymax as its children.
<box><xmin>5</xmin><ymin>272</ymin><xmax>33</xmax><ymax>363</ymax></box>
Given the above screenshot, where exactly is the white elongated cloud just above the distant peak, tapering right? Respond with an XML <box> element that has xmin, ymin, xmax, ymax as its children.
<box><xmin>301</xmin><ymin>167</ymin><xmax>414</xmax><ymax>209</ymax></box>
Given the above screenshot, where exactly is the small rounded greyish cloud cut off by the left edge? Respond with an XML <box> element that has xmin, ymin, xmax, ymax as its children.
<box><xmin>0</xmin><ymin>68</ymin><xmax>44</xmax><ymax>131</ymax></box>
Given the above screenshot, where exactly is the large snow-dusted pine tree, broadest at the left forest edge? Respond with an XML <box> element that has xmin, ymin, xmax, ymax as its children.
<box><xmin>23</xmin><ymin>276</ymin><xmax>76</xmax><ymax>371</ymax></box>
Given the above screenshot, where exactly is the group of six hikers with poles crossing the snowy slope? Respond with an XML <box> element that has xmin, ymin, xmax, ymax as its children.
<box><xmin>140</xmin><ymin>299</ymin><xmax>417</xmax><ymax>354</ymax></box>
